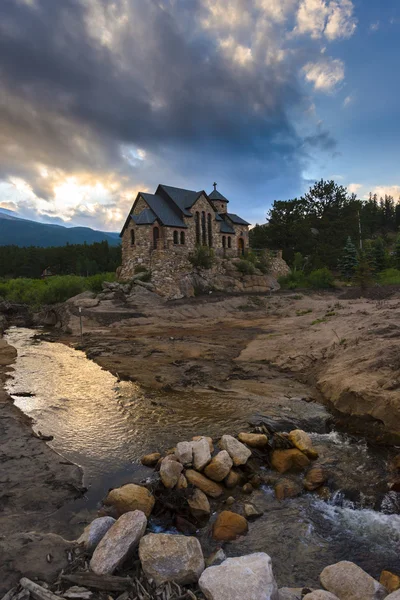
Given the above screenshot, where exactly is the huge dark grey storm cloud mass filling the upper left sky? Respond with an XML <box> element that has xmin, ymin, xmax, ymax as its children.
<box><xmin>0</xmin><ymin>0</ymin><xmax>334</xmax><ymax>218</ymax></box>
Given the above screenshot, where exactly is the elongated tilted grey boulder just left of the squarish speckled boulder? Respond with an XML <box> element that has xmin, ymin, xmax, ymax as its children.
<box><xmin>90</xmin><ymin>510</ymin><xmax>147</xmax><ymax>575</ymax></box>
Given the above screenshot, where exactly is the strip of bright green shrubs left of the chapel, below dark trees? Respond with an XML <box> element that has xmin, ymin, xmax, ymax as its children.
<box><xmin>0</xmin><ymin>273</ymin><xmax>115</xmax><ymax>307</ymax></box>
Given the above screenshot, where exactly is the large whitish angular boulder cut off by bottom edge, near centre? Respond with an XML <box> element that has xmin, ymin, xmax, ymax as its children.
<box><xmin>199</xmin><ymin>552</ymin><xmax>279</xmax><ymax>600</ymax></box>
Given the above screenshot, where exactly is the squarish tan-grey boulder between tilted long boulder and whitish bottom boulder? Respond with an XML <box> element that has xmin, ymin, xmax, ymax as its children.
<box><xmin>139</xmin><ymin>533</ymin><xmax>205</xmax><ymax>585</ymax></box>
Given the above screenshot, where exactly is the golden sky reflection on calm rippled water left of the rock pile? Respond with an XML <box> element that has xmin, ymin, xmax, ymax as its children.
<box><xmin>7</xmin><ymin>328</ymin><xmax>284</xmax><ymax>480</ymax></box>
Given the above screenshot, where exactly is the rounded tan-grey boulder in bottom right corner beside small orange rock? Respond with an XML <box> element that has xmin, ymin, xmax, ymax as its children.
<box><xmin>320</xmin><ymin>560</ymin><xmax>387</xmax><ymax>600</ymax></box>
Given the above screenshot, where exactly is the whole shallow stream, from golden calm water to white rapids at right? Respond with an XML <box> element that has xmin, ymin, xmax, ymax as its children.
<box><xmin>6</xmin><ymin>328</ymin><xmax>400</xmax><ymax>586</ymax></box>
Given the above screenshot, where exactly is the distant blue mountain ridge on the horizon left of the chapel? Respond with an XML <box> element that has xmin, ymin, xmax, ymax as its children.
<box><xmin>0</xmin><ymin>208</ymin><xmax>120</xmax><ymax>248</ymax></box>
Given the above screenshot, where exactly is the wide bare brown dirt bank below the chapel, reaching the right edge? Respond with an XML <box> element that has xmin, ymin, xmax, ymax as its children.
<box><xmin>58</xmin><ymin>290</ymin><xmax>400</xmax><ymax>443</ymax></box>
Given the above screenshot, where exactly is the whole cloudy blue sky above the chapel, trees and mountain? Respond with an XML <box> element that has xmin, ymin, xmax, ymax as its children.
<box><xmin>0</xmin><ymin>0</ymin><xmax>400</xmax><ymax>231</ymax></box>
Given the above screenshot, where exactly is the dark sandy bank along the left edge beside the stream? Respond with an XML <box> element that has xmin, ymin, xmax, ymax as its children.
<box><xmin>0</xmin><ymin>338</ymin><xmax>82</xmax><ymax>591</ymax></box>
